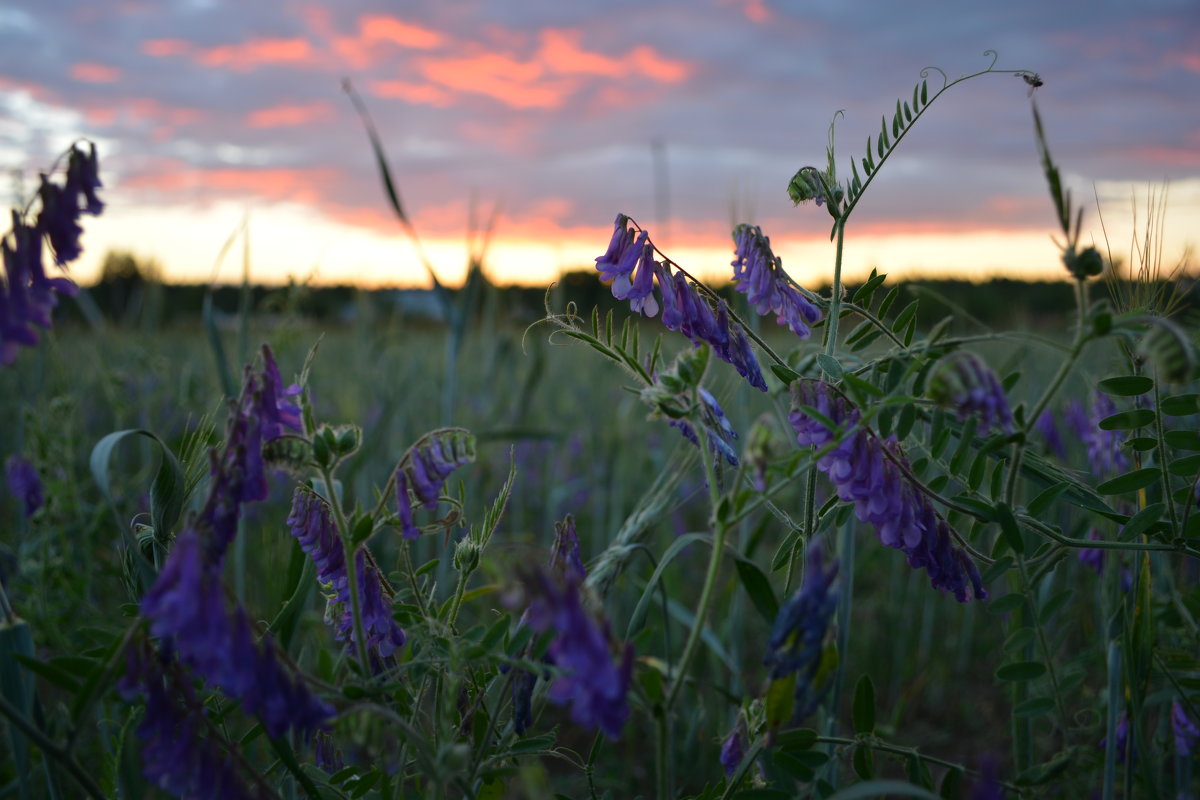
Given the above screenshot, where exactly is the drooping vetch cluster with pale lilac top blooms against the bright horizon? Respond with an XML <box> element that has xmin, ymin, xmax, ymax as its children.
<box><xmin>596</xmin><ymin>213</ymin><xmax>767</xmax><ymax>391</ymax></box>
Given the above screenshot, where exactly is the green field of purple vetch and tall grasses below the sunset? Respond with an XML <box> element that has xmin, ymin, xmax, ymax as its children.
<box><xmin>0</xmin><ymin>61</ymin><xmax>1200</xmax><ymax>800</ymax></box>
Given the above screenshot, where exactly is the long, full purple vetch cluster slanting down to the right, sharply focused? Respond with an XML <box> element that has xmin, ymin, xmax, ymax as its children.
<box><xmin>788</xmin><ymin>380</ymin><xmax>988</xmax><ymax>602</ymax></box>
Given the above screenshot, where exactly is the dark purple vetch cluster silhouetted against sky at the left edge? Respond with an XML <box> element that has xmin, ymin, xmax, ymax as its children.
<box><xmin>0</xmin><ymin>144</ymin><xmax>104</xmax><ymax>366</ymax></box>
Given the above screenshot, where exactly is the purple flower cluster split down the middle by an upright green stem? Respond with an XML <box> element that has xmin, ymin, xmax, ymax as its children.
<box><xmin>288</xmin><ymin>487</ymin><xmax>406</xmax><ymax>666</ymax></box>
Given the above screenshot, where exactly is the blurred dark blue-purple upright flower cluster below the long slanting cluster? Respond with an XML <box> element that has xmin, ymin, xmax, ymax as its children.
<box><xmin>763</xmin><ymin>542</ymin><xmax>838</xmax><ymax>722</ymax></box>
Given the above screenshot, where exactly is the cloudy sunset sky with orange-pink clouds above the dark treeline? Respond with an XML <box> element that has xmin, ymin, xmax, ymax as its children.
<box><xmin>0</xmin><ymin>0</ymin><xmax>1200</xmax><ymax>287</ymax></box>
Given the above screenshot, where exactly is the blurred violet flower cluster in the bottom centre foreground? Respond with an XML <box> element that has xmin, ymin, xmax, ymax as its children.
<box><xmin>513</xmin><ymin>571</ymin><xmax>634</xmax><ymax>739</ymax></box>
